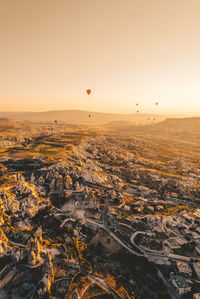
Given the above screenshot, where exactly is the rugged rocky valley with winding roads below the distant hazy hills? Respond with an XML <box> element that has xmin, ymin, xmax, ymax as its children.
<box><xmin>0</xmin><ymin>121</ymin><xmax>200</xmax><ymax>299</ymax></box>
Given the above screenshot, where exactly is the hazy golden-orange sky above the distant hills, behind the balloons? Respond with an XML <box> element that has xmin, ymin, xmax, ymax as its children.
<box><xmin>0</xmin><ymin>0</ymin><xmax>200</xmax><ymax>115</ymax></box>
